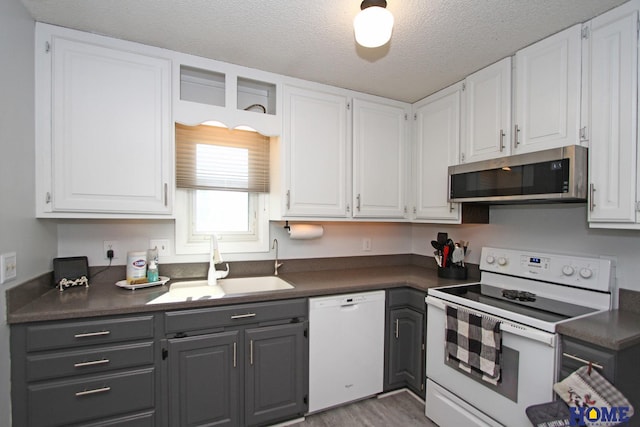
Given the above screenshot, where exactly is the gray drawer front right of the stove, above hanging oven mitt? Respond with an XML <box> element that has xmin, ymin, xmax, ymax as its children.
<box><xmin>560</xmin><ymin>338</ymin><xmax>616</xmax><ymax>383</ymax></box>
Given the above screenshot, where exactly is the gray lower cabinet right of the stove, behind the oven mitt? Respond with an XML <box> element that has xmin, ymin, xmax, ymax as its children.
<box><xmin>560</xmin><ymin>336</ymin><xmax>640</xmax><ymax>427</ymax></box>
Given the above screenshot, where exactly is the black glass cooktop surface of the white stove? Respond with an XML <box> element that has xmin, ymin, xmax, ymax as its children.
<box><xmin>438</xmin><ymin>283</ymin><xmax>598</xmax><ymax>322</ymax></box>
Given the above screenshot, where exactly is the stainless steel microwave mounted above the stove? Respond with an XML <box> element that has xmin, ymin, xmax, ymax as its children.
<box><xmin>449</xmin><ymin>145</ymin><xmax>587</xmax><ymax>204</ymax></box>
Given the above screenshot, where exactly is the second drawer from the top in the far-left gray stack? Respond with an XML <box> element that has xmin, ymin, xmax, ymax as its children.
<box><xmin>27</xmin><ymin>341</ymin><xmax>154</xmax><ymax>381</ymax></box>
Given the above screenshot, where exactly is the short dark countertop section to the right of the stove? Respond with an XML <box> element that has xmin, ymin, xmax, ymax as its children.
<box><xmin>558</xmin><ymin>310</ymin><xmax>640</xmax><ymax>351</ymax></box>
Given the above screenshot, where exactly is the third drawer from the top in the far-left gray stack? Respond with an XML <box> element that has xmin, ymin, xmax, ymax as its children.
<box><xmin>27</xmin><ymin>368</ymin><xmax>155</xmax><ymax>427</ymax></box>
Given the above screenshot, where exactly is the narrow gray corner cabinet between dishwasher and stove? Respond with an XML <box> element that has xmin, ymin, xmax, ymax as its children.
<box><xmin>385</xmin><ymin>288</ymin><xmax>426</xmax><ymax>397</ymax></box>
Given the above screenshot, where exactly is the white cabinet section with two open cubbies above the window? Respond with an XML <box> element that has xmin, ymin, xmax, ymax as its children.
<box><xmin>173</xmin><ymin>53</ymin><xmax>282</xmax><ymax>136</ymax></box>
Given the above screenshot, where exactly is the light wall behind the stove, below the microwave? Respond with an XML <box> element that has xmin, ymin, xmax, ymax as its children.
<box><xmin>412</xmin><ymin>204</ymin><xmax>640</xmax><ymax>291</ymax></box>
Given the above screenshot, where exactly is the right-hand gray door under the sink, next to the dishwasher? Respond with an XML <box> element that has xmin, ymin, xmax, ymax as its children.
<box><xmin>245</xmin><ymin>322</ymin><xmax>308</xmax><ymax>425</ymax></box>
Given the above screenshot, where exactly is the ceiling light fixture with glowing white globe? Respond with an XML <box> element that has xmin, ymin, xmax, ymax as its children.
<box><xmin>353</xmin><ymin>0</ymin><xmax>393</xmax><ymax>47</ymax></box>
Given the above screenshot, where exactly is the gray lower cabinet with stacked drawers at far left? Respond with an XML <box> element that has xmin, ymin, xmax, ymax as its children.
<box><xmin>11</xmin><ymin>315</ymin><xmax>157</xmax><ymax>427</ymax></box>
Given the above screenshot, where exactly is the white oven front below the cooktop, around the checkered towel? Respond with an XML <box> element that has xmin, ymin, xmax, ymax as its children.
<box><xmin>425</xmin><ymin>296</ymin><xmax>558</xmax><ymax>427</ymax></box>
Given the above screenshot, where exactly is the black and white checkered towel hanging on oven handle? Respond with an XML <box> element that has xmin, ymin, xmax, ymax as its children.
<box><xmin>445</xmin><ymin>306</ymin><xmax>502</xmax><ymax>385</ymax></box>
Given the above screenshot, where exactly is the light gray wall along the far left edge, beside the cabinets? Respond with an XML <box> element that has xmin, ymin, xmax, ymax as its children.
<box><xmin>0</xmin><ymin>0</ymin><xmax>57</xmax><ymax>426</ymax></box>
